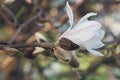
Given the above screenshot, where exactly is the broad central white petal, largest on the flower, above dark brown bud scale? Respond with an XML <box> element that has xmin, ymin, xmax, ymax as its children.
<box><xmin>63</xmin><ymin>21</ymin><xmax>101</xmax><ymax>45</ymax></box>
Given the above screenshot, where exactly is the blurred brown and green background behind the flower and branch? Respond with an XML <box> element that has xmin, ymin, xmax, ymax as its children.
<box><xmin>0</xmin><ymin>0</ymin><xmax>120</xmax><ymax>80</ymax></box>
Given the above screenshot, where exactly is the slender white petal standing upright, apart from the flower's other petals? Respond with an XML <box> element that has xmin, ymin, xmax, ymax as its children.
<box><xmin>66</xmin><ymin>2</ymin><xmax>73</xmax><ymax>27</ymax></box>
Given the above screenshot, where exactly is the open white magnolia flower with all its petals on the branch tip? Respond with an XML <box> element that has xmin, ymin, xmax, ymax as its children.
<box><xmin>58</xmin><ymin>2</ymin><xmax>105</xmax><ymax>56</ymax></box>
